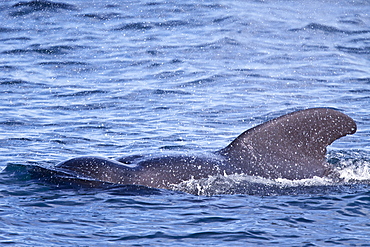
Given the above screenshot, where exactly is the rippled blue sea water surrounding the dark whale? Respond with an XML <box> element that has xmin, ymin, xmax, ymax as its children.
<box><xmin>0</xmin><ymin>0</ymin><xmax>370</xmax><ymax>246</ymax></box>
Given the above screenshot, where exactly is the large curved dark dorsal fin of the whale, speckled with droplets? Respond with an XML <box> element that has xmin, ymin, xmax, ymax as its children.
<box><xmin>219</xmin><ymin>108</ymin><xmax>356</xmax><ymax>179</ymax></box>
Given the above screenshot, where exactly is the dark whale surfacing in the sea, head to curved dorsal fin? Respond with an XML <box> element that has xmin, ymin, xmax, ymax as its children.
<box><xmin>55</xmin><ymin>108</ymin><xmax>356</xmax><ymax>189</ymax></box>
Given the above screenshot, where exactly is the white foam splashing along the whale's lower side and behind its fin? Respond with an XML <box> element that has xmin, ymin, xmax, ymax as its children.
<box><xmin>173</xmin><ymin>160</ymin><xmax>370</xmax><ymax>195</ymax></box>
